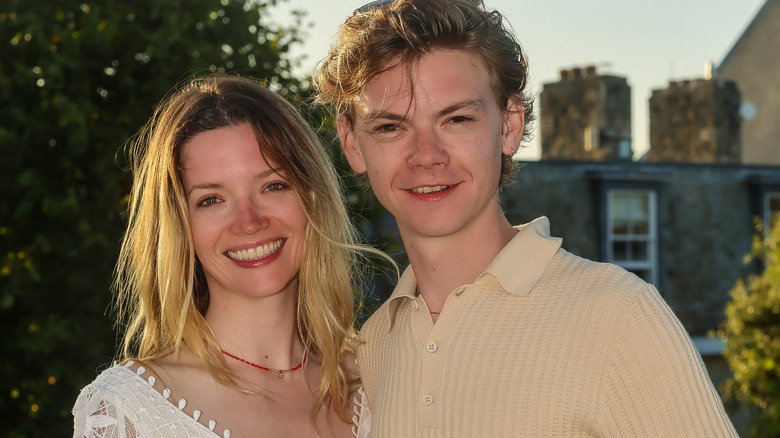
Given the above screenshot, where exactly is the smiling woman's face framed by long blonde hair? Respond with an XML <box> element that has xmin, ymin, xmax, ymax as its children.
<box><xmin>181</xmin><ymin>124</ymin><xmax>306</xmax><ymax>306</ymax></box>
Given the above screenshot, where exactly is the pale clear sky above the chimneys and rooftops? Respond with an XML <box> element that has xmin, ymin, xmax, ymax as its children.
<box><xmin>273</xmin><ymin>0</ymin><xmax>765</xmax><ymax>160</ymax></box>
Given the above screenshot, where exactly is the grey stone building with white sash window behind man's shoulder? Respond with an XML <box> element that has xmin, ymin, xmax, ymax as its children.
<box><xmin>501</xmin><ymin>160</ymin><xmax>780</xmax><ymax>337</ymax></box>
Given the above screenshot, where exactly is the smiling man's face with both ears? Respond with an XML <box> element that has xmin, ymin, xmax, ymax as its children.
<box><xmin>338</xmin><ymin>50</ymin><xmax>523</xmax><ymax>240</ymax></box>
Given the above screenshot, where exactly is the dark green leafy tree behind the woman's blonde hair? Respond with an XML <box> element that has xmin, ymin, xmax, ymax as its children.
<box><xmin>0</xmin><ymin>0</ymin><xmax>310</xmax><ymax>437</ymax></box>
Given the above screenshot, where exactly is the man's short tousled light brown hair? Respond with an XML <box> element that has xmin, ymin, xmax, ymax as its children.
<box><xmin>312</xmin><ymin>0</ymin><xmax>534</xmax><ymax>183</ymax></box>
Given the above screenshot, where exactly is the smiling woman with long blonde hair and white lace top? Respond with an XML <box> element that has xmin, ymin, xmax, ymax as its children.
<box><xmin>73</xmin><ymin>76</ymin><xmax>371</xmax><ymax>438</ymax></box>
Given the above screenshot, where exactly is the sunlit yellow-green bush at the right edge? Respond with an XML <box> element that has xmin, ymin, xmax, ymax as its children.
<box><xmin>719</xmin><ymin>220</ymin><xmax>780</xmax><ymax>437</ymax></box>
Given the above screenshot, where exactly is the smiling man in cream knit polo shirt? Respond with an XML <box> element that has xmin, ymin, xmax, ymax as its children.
<box><xmin>314</xmin><ymin>0</ymin><xmax>736</xmax><ymax>437</ymax></box>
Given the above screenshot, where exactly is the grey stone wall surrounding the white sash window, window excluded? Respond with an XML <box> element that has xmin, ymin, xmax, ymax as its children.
<box><xmin>502</xmin><ymin>161</ymin><xmax>780</xmax><ymax>336</ymax></box>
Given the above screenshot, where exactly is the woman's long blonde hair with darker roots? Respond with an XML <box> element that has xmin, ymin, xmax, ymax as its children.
<box><xmin>114</xmin><ymin>75</ymin><xmax>368</xmax><ymax>417</ymax></box>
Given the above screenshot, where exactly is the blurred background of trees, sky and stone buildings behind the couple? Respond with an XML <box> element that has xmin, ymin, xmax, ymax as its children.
<box><xmin>0</xmin><ymin>0</ymin><xmax>780</xmax><ymax>437</ymax></box>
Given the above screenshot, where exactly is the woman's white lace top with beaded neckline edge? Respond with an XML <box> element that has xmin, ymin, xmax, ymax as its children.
<box><xmin>73</xmin><ymin>362</ymin><xmax>371</xmax><ymax>438</ymax></box>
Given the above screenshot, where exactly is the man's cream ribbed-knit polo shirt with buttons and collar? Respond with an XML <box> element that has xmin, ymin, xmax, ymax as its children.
<box><xmin>358</xmin><ymin>218</ymin><xmax>737</xmax><ymax>438</ymax></box>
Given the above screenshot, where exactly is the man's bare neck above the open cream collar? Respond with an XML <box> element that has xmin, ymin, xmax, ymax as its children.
<box><xmin>401</xmin><ymin>212</ymin><xmax>516</xmax><ymax>312</ymax></box>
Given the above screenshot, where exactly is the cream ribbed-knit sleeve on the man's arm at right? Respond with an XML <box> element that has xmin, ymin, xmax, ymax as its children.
<box><xmin>600</xmin><ymin>285</ymin><xmax>738</xmax><ymax>437</ymax></box>
